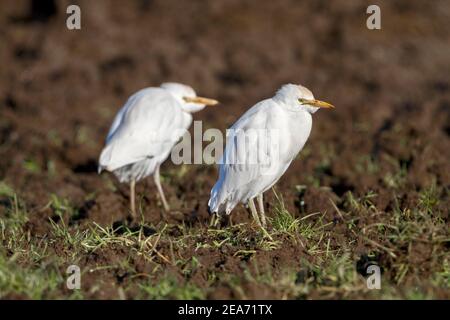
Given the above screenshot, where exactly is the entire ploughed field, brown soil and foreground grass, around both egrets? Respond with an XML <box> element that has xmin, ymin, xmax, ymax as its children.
<box><xmin>0</xmin><ymin>0</ymin><xmax>450</xmax><ymax>299</ymax></box>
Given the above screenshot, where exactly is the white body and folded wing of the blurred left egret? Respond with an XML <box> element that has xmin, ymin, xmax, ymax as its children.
<box><xmin>100</xmin><ymin>88</ymin><xmax>192</xmax><ymax>171</ymax></box>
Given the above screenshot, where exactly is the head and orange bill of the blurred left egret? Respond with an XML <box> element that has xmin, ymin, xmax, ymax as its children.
<box><xmin>161</xmin><ymin>82</ymin><xmax>218</xmax><ymax>113</ymax></box>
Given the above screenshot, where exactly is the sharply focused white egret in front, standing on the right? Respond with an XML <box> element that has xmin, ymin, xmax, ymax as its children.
<box><xmin>208</xmin><ymin>84</ymin><xmax>334</xmax><ymax>226</ymax></box>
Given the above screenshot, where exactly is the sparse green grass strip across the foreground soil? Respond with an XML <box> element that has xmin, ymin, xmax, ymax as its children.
<box><xmin>0</xmin><ymin>182</ymin><xmax>450</xmax><ymax>299</ymax></box>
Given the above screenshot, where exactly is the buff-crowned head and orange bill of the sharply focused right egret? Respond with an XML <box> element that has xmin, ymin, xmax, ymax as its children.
<box><xmin>274</xmin><ymin>84</ymin><xmax>334</xmax><ymax>114</ymax></box>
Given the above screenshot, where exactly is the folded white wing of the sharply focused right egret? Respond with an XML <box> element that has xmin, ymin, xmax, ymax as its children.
<box><xmin>209</xmin><ymin>100</ymin><xmax>285</xmax><ymax>213</ymax></box>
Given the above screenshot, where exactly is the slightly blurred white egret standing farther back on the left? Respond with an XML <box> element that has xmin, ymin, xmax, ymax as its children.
<box><xmin>98</xmin><ymin>83</ymin><xmax>218</xmax><ymax>217</ymax></box>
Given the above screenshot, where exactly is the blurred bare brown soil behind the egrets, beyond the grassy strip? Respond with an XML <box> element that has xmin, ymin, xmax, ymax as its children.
<box><xmin>0</xmin><ymin>0</ymin><xmax>450</xmax><ymax>297</ymax></box>
